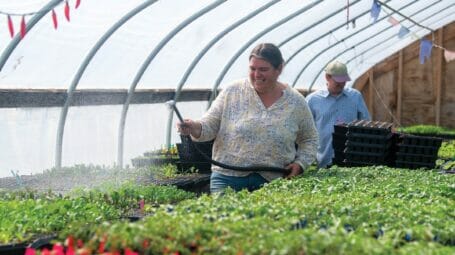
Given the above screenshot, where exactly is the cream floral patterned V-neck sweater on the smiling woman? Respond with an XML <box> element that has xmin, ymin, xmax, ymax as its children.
<box><xmin>192</xmin><ymin>79</ymin><xmax>318</xmax><ymax>181</ymax></box>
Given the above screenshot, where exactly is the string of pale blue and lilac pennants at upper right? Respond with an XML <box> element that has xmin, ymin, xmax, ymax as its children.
<box><xmin>370</xmin><ymin>0</ymin><xmax>455</xmax><ymax>64</ymax></box>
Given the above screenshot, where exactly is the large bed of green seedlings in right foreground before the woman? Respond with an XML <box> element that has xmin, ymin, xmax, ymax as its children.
<box><xmin>60</xmin><ymin>166</ymin><xmax>455</xmax><ymax>254</ymax></box>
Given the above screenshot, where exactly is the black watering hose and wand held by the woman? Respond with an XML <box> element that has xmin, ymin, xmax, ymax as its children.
<box><xmin>165</xmin><ymin>100</ymin><xmax>290</xmax><ymax>174</ymax></box>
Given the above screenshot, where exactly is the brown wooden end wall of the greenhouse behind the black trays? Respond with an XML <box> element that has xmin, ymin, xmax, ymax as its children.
<box><xmin>354</xmin><ymin>22</ymin><xmax>455</xmax><ymax>128</ymax></box>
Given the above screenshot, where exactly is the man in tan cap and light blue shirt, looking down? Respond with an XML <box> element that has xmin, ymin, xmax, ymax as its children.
<box><xmin>307</xmin><ymin>60</ymin><xmax>370</xmax><ymax>167</ymax></box>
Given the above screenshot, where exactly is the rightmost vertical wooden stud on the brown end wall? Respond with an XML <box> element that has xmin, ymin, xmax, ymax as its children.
<box><xmin>433</xmin><ymin>28</ymin><xmax>444</xmax><ymax>126</ymax></box>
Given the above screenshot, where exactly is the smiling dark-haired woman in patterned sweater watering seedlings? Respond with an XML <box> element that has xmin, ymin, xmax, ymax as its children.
<box><xmin>178</xmin><ymin>43</ymin><xmax>318</xmax><ymax>193</ymax></box>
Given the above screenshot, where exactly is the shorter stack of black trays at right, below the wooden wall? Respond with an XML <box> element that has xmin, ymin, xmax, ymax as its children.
<box><xmin>395</xmin><ymin>134</ymin><xmax>442</xmax><ymax>169</ymax></box>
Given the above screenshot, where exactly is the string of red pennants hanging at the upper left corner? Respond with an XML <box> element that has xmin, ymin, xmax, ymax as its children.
<box><xmin>0</xmin><ymin>0</ymin><xmax>81</xmax><ymax>39</ymax></box>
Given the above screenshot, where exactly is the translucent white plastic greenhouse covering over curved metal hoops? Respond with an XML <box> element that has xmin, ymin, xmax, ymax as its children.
<box><xmin>0</xmin><ymin>0</ymin><xmax>455</xmax><ymax>177</ymax></box>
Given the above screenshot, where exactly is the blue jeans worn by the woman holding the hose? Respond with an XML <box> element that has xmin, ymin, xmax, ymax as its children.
<box><xmin>210</xmin><ymin>172</ymin><xmax>268</xmax><ymax>193</ymax></box>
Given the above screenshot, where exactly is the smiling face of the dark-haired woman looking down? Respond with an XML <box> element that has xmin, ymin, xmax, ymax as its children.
<box><xmin>249</xmin><ymin>57</ymin><xmax>283</xmax><ymax>93</ymax></box>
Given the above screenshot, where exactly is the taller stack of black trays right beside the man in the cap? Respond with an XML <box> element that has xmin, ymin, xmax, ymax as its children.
<box><xmin>344</xmin><ymin>120</ymin><xmax>395</xmax><ymax>166</ymax></box>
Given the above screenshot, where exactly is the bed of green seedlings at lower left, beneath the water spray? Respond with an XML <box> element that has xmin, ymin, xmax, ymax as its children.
<box><xmin>0</xmin><ymin>184</ymin><xmax>195</xmax><ymax>243</ymax></box>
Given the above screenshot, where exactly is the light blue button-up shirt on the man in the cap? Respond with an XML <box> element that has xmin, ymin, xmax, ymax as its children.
<box><xmin>306</xmin><ymin>88</ymin><xmax>370</xmax><ymax>167</ymax></box>
